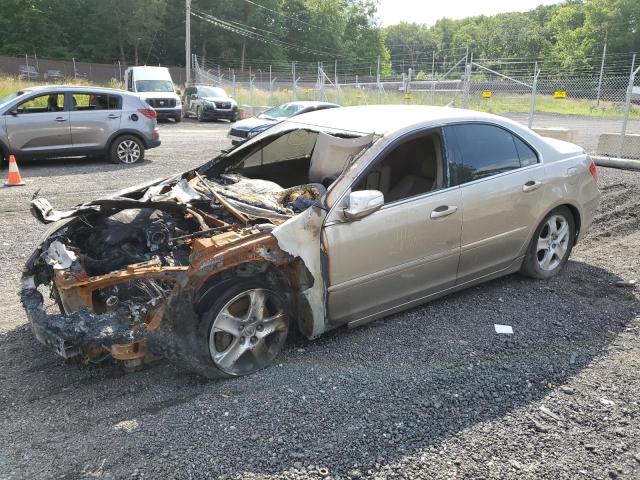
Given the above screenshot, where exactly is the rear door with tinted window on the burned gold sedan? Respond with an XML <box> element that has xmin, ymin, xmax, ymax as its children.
<box><xmin>445</xmin><ymin>123</ymin><xmax>544</xmax><ymax>284</ymax></box>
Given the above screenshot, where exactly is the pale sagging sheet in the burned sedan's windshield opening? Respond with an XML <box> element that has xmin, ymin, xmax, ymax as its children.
<box><xmin>309</xmin><ymin>132</ymin><xmax>374</xmax><ymax>183</ymax></box>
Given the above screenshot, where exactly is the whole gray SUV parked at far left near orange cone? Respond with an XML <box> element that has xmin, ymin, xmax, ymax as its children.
<box><xmin>0</xmin><ymin>85</ymin><xmax>160</xmax><ymax>164</ymax></box>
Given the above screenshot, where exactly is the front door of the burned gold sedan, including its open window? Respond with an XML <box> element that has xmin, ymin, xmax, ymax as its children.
<box><xmin>323</xmin><ymin>129</ymin><xmax>462</xmax><ymax>324</ymax></box>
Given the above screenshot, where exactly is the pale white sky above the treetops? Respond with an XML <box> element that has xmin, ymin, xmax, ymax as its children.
<box><xmin>378</xmin><ymin>0</ymin><xmax>560</xmax><ymax>26</ymax></box>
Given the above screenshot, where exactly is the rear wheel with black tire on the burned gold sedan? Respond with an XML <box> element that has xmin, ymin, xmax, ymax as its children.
<box><xmin>520</xmin><ymin>207</ymin><xmax>576</xmax><ymax>279</ymax></box>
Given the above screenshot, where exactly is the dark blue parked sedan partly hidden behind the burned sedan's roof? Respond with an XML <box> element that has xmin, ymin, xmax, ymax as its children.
<box><xmin>229</xmin><ymin>101</ymin><xmax>340</xmax><ymax>145</ymax></box>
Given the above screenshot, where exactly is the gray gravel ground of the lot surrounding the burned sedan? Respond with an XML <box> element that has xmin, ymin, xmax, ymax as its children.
<box><xmin>0</xmin><ymin>117</ymin><xmax>640</xmax><ymax>480</ymax></box>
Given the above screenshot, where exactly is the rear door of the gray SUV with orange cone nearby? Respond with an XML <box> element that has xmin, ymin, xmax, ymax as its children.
<box><xmin>68</xmin><ymin>92</ymin><xmax>122</xmax><ymax>150</ymax></box>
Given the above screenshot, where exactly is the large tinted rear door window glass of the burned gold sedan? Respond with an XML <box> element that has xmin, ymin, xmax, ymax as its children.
<box><xmin>447</xmin><ymin>124</ymin><xmax>520</xmax><ymax>185</ymax></box>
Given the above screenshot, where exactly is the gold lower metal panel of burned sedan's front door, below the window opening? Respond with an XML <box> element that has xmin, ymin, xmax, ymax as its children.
<box><xmin>323</xmin><ymin>188</ymin><xmax>462</xmax><ymax>323</ymax></box>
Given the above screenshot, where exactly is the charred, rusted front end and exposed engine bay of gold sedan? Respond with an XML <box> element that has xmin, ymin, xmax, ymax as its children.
<box><xmin>20</xmin><ymin>167</ymin><xmax>323</xmax><ymax>369</ymax></box>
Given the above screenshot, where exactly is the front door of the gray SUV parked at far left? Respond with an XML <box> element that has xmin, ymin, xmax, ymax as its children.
<box><xmin>5</xmin><ymin>93</ymin><xmax>71</xmax><ymax>154</ymax></box>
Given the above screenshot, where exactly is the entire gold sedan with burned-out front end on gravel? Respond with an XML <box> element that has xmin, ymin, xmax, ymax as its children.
<box><xmin>21</xmin><ymin>106</ymin><xmax>600</xmax><ymax>377</ymax></box>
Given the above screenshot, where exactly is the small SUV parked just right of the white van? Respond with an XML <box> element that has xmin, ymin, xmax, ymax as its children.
<box><xmin>182</xmin><ymin>85</ymin><xmax>238</xmax><ymax>122</ymax></box>
